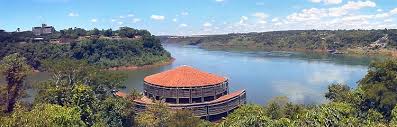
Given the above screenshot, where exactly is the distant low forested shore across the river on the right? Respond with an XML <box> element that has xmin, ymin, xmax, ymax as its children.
<box><xmin>160</xmin><ymin>29</ymin><xmax>397</xmax><ymax>50</ymax></box>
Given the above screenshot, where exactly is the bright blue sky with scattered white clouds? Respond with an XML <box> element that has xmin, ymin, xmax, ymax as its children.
<box><xmin>0</xmin><ymin>0</ymin><xmax>397</xmax><ymax>35</ymax></box>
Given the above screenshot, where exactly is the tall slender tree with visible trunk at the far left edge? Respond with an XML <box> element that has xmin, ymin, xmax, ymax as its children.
<box><xmin>1</xmin><ymin>54</ymin><xmax>32</xmax><ymax>113</ymax></box>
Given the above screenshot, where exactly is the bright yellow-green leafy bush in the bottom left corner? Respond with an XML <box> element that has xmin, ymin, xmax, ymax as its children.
<box><xmin>0</xmin><ymin>104</ymin><xmax>86</xmax><ymax>127</ymax></box>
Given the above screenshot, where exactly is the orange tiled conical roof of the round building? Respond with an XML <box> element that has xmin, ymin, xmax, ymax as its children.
<box><xmin>144</xmin><ymin>66</ymin><xmax>227</xmax><ymax>87</ymax></box>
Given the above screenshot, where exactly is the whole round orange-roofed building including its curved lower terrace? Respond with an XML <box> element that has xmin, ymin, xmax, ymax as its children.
<box><xmin>130</xmin><ymin>66</ymin><xmax>246</xmax><ymax>120</ymax></box>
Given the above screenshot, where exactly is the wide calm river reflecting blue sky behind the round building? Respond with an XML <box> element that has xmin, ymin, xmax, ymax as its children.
<box><xmin>27</xmin><ymin>44</ymin><xmax>380</xmax><ymax>104</ymax></box>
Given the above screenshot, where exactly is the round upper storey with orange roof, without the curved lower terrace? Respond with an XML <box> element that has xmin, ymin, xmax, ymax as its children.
<box><xmin>144</xmin><ymin>66</ymin><xmax>228</xmax><ymax>104</ymax></box>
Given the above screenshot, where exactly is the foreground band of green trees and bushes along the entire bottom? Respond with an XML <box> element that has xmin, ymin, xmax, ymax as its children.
<box><xmin>0</xmin><ymin>50</ymin><xmax>397</xmax><ymax>127</ymax></box>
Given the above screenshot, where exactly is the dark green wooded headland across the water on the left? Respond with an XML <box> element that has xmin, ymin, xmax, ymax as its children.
<box><xmin>0</xmin><ymin>27</ymin><xmax>171</xmax><ymax>69</ymax></box>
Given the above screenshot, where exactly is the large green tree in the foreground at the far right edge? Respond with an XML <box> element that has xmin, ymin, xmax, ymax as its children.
<box><xmin>359</xmin><ymin>60</ymin><xmax>397</xmax><ymax>118</ymax></box>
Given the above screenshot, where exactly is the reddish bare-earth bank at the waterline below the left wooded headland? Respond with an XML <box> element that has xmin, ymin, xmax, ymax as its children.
<box><xmin>106</xmin><ymin>57</ymin><xmax>175</xmax><ymax>71</ymax></box>
